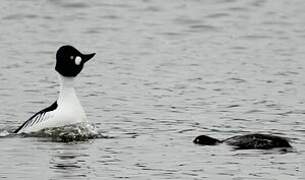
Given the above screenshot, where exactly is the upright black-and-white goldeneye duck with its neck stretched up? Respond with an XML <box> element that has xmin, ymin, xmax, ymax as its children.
<box><xmin>14</xmin><ymin>45</ymin><xmax>95</xmax><ymax>133</ymax></box>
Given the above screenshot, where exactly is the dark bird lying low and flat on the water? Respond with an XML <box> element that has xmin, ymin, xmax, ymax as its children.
<box><xmin>193</xmin><ymin>134</ymin><xmax>291</xmax><ymax>149</ymax></box>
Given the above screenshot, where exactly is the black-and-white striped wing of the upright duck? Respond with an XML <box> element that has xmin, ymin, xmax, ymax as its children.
<box><xmin>14</xmin><ymin>101</ymin><xmax>57</xmax><ymax>133</ymax></box>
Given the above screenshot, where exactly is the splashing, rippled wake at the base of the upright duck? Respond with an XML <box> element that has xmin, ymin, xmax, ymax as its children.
<box><xmin>0</xmin><ymin>123</ymin><xmax>107</xmax><ymax>142</ymax></box>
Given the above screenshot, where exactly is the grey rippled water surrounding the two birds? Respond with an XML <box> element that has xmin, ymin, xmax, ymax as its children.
<box><xmin>0</xmin><ymin>0</ymin><xmax>305</xmax><ymax>180</ymax></box>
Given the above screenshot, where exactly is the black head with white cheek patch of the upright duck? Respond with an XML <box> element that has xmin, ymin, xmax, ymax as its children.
<box><xmin>55</xmin><ymin>45</ymin><xmax>95</xmax><ymax>77</ymax></box>
